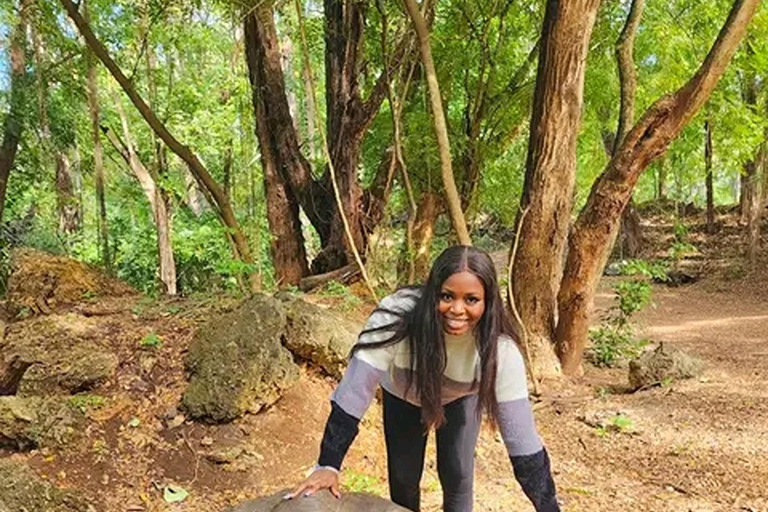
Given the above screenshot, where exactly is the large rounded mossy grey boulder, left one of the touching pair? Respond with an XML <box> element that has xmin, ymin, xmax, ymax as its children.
<box><xmin>182</xmin><ymin>295</ymin><xmax>299</xmax><ymax>422</ymax></box>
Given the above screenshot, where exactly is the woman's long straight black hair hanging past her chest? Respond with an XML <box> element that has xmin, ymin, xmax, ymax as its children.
<box><xmin>352</xmin><ymin>245</ymin><xmax>517</xmax><ymax>429</ymax></box>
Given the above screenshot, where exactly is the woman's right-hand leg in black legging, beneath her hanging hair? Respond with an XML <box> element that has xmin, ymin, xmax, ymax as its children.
<box><xmin>437</xmin><ymin>395</ymin><xmax>480</xmax><ymax>512</ymax></box>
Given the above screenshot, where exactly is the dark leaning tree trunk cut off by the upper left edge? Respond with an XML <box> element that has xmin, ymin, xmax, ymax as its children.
<box><xmin>0</xmin><ymin>0</ymin><xmax>32</xmax><ymax>221</ymax></box>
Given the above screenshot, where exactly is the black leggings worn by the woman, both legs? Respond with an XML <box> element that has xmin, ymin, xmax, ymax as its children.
<box><xmin>384</xmin><ymin>391</ymin><xmax>480</xmax><ymax>512</ymax></box>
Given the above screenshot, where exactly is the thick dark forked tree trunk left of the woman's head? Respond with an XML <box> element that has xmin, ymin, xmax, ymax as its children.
<box><xmin>244</xmin><ymin>0</ymin><xmax>416</xmax><ymax>284</ymax></box>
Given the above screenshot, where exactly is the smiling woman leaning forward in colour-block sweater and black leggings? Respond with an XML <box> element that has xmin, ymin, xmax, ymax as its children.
<box><xmin>286</xmin><ymin>246</ymin><xmax>560</xmax><ymax>512</ymax></box>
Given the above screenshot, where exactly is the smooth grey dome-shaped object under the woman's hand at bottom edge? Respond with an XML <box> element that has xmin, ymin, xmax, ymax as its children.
<box><xmin>226</xmin><ymin>489</ymin><xmax>407</xmax><ymax>512</ymax></box>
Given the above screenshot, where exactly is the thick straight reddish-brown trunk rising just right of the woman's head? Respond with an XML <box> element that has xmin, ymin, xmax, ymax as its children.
<box><xmin>513</xmin><ymin>0</ymin><xmax>600</xmax><ymax>378</ymax></box>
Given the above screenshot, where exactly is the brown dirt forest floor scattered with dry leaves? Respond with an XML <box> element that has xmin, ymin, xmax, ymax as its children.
<box><xmin>0</xmin><ymin>209</ymin><xmax>768</xmax><ymax>512</ymax></box>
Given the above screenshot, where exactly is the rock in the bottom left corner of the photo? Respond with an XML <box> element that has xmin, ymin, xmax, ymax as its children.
<box><xmin>0</xmin><ymin>459</ymin><xmax>89</xmax><ymax>512</ymax></box>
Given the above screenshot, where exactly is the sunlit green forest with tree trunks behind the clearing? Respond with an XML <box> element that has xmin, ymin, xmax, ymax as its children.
<box><xmin>0</xmin><ymin>0</ymin><xmax>768</xmax><ymax>375</ymax></box>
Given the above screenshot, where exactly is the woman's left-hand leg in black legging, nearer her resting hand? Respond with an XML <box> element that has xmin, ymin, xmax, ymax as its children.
<box><xmin>384</xmin><ymin>391</ymin><xmax>427</xmax><ymax>512</ymax></box>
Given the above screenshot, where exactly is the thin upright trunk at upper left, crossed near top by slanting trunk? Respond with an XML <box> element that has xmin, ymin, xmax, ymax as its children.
<box><xmin>83</xmin><ymin>0</ymin><xmax>112</xmax><ymax>272</ymax></box>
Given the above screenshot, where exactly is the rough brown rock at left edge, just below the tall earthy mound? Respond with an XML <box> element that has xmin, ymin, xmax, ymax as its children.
<box><xmin>0</xmin><ymin>313</ymin><xmax>119</xmax><ymax>396</ymax></box>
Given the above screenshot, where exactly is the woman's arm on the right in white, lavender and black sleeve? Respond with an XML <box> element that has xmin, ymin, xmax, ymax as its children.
<box><xmin>496</xmin><ymin>340</ymin><xmax>560</xmax><ymax>512</ymax></box>
